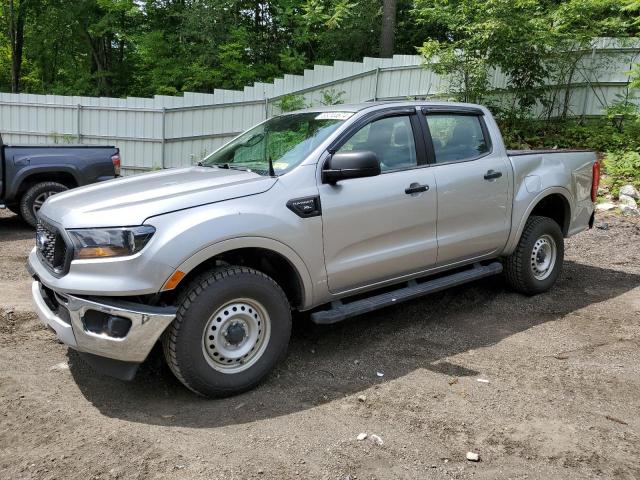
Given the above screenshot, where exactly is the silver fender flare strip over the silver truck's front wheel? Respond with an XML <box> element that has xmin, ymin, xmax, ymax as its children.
<box><xmin>168</xmin><ymin>237</ymin><xmax>313</xmax><ymax>305</ymax></box>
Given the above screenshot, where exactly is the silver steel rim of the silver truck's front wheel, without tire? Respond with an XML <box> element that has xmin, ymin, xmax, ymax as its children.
<box><xmin>202</xmin><ymin>298</ymin><xmax>271</xmax><ymax>374</ymax></box>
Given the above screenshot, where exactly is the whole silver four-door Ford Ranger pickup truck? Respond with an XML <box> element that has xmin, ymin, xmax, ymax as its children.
<box><xmin>28</xmin><ymin>102</ymin><xmax>599</xmax><ymax>397</ymax></box>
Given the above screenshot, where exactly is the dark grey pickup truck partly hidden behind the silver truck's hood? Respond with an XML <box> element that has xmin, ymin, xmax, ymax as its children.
<box><xmin>0</xmin><ymin>133</ymin><xmax>120</xmax><ymax>227</ymax></box>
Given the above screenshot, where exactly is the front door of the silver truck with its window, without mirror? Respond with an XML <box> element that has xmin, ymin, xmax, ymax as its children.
<box><xmin>319</xmin><ymin>114</ymin><xmax>437</xmax><ymax>293</ymax></box>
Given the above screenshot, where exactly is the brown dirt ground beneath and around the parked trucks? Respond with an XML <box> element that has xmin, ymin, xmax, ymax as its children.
<box><xmin>0</xmin><ymin>213</ymin><xmax>640</xmax><ymax>479</ymax></box>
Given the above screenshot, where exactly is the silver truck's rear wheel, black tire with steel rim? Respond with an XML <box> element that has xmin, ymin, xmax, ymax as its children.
<box><xmin>504</xmin><ymin>216</ymin><xmax>564</xmax><ymax>295</ymax></box>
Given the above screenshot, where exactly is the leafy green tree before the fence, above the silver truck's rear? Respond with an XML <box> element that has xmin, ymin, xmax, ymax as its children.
<box><xmin>414</xmin><ymin>0</ymin><xmax>633</xmax><ymax>119</ymax></box>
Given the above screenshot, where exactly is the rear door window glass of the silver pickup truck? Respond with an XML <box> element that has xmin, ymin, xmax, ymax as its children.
<box><xmin>427</xmin><ymin>114</ymin><xmax>489</xmax><ymax>163</ymax></box>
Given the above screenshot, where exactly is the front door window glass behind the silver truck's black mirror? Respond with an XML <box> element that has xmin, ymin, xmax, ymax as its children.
<box><xmin>339</xmin><ymin>116</ymin><xmax>418</xmax><ymax>172</ymax></box>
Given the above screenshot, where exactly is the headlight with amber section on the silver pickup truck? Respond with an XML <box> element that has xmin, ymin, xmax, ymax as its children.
<box><xmin>67</xmin><ymin>225</ymin><xmax>156</xmax><ymax>259</ymax></box>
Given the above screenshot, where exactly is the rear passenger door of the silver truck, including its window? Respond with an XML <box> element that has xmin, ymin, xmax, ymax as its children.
<box><xmin>423</xmin><ymin>109</ymin><xmax>510</xmax><ymax>265</ymax></box>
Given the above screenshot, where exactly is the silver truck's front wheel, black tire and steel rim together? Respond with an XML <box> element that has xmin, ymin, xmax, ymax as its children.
<box><xmin>162</xmin><ymin>266</ymin><xmax>291</xmax><ymax>397</ymax></box>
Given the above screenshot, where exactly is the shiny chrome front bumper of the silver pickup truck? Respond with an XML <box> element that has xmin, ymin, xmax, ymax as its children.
<box><xmin>31</xmin><ymin>280</ymin><xmax>176</xmax><ymax>363</ymax></box>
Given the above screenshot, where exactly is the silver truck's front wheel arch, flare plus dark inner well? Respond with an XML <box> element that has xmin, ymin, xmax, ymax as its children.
<box><xmin>165</xmin><ymin>237</ymin><xmax>313</xmax><ymax>309</ymax></box>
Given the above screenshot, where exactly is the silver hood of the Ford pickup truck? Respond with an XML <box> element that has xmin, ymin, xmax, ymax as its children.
<box><xmin>40</xmin><ymin>167</ymin><xmax>276</xmax><ymax>228</ymax></box>
